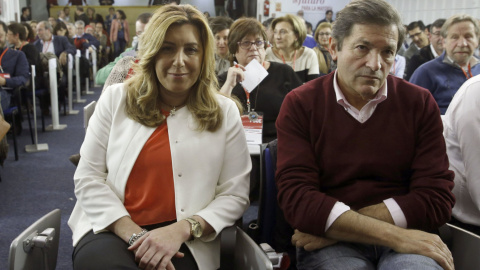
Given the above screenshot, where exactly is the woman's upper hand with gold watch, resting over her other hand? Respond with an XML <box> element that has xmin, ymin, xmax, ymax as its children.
<box><xmin>128</xmin><ymin>220</ymin><xmax>190</xmax><ymax>270</ymax></box>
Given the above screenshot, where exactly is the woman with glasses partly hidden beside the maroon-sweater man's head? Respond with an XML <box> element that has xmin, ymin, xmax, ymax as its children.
<box><xmin>313</xmin><ymin>22</ymin><xmax>335</xmax><ymax>74</ymax></box>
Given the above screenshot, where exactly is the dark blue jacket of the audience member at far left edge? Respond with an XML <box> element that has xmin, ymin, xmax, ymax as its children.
<box><xmin>0</xmin><ymin>48</ymin><xmax>30</xmax><ymax>88</ymax></box>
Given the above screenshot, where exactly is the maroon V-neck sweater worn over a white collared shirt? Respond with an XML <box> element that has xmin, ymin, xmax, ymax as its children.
<box><xmin>276</xmin><ymin>72</ymin><xmax>455</xmax><ymax>235</ymax></box>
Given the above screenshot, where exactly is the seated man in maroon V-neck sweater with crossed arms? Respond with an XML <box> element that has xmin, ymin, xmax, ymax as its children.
<box><xmin>276</xmin><ymin>0</ymin><xmax>455</xmax><ymax>270</ymax></box>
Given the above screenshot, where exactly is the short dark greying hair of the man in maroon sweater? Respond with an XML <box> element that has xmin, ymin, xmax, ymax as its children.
<box><xmin>332</xmin><ymin>0</ymin><xmax>405</xmax><ymax>51</ymax></box>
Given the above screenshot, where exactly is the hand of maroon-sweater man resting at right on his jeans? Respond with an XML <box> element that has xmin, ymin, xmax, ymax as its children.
<box><xmin>392</xmin><ymin>229</ymin><xmax>455</xmax><ymax>270</ymax></box>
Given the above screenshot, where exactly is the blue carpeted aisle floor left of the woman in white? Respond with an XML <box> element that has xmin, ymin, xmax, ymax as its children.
<box><xmin>0</xmin><ymin>88</ymin><xmax>101</xmax><ymax>270</ymax></box>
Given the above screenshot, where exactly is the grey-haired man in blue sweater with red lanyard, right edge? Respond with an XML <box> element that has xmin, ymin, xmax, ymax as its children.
<box><xmin>410</xmin><ymin>15</ymin><xmax>480</xmax><ymax>114</ymax></box>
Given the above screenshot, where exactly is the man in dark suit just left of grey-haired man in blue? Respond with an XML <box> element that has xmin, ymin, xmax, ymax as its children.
<box><xmin>404</xmin><ymin>19</ymin><xmax>445</xmax><ymax>81</ymax></box>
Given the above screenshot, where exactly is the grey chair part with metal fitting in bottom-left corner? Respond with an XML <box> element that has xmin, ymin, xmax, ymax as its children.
<box><xmin>8</xmin><ymin>209</ymin><xmax>60</xmax><ymax>270</ymax></box>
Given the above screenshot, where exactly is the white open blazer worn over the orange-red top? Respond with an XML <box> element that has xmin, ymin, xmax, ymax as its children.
<box><xmin>68</xmin><ymin>84</ymin><xmax>251</xmax><ymax>270</ymax></box>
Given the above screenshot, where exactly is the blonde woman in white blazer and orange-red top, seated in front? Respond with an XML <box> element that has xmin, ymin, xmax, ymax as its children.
<box><xmin>68</xmin><ymin>5</ymin><xmax>251</xmax><ymax>270</ymax></box>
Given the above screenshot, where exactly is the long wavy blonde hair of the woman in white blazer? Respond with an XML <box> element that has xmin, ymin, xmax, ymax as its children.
<box><xmin>125</xmin><ymin>5</ymin><xmax>223</xmax><ymax>131</ymax></box>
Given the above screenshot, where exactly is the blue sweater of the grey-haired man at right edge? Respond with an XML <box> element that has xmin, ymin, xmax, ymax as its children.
<box><xmin>410</xmin><ymin>52</ymin><xmax>480</xmax><ymax>114</ymax></box>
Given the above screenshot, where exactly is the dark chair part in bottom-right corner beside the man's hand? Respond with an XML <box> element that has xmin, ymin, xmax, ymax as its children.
<box><xmin>440</xmin><ymin>223</ymin><xmax>480</xmax><ymax>270</ymax></box>
